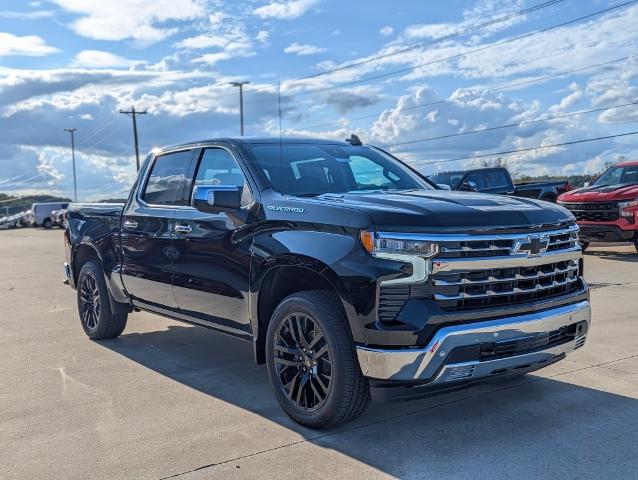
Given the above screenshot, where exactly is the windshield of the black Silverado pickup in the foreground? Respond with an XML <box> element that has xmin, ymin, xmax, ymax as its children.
<box><xmin>246</xmin><ymin>144</ymin><xmax>433</xmax><ymax>196</ymax></box>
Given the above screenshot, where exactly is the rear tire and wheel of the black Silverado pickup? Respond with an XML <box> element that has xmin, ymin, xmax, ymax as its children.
<box><xmin>77</xmin><ymin>260</ymin><xmax>128</xmax><ymax>340</ymax></box>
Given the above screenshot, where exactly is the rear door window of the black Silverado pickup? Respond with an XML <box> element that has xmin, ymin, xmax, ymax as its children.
<box><xmin>142</xmin><ymin>150</ymin><xmax>193</xmax><ymax>205</ymax></box>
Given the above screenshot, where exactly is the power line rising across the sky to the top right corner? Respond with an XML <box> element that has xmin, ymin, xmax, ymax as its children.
<box><xmin>246</xmin><ymin>0</ymin><xmax>638</xmax><ymax>103</ymax></box>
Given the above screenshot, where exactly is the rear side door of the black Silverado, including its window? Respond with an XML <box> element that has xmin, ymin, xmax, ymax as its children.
<box><xmin>121</xmin><ymin>150</ymin><xmax>193</xmax><ymax>309</ymax></box>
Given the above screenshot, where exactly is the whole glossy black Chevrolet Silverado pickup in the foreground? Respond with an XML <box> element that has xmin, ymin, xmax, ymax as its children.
<box><xmin>65</xmin><ymin>138</ymin><xmax>590</xmax><ymax>428</ymax></box>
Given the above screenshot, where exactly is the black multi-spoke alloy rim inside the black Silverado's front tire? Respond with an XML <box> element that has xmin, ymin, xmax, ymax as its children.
<box><xmin>274</xmin><ymin>312</ymin><xmax>332</xmax><ymax>411</ymax></box>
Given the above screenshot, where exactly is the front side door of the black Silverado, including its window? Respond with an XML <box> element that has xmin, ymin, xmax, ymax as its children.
<box><xmin>173</xmin><ymin>147</ymin><xmax>256</xmax><ymax>334</ymax></box>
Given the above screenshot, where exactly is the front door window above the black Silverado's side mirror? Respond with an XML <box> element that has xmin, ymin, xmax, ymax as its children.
<box><xmin>195</xmin><ymin>148</ymin><xmax>252</xmax><ymax>206</ymax></box>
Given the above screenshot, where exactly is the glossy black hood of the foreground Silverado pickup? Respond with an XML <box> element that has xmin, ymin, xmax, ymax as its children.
<box><xmin>319</xmin><ymin>190</ymin><xmax>575</xmax><ymax>231</ymax></box>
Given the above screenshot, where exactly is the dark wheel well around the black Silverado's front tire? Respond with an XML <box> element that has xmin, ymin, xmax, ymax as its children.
<box><xmin>255</xmin><ymin>266</ymin><xmax>336</xmax><ymax>364</ymax></box>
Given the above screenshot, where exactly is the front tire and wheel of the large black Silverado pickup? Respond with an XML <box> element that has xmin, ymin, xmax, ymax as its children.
<box><xmin>266</xmin><ymin>290</ymin><xmax>370</xmax><ymax>428</ymax></box>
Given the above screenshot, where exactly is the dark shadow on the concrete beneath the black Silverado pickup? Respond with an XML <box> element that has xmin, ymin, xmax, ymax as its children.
<box><xmin>101</xmin><ymin>325</ymin><xmax>638</xmax><ymax>478</ymax></box>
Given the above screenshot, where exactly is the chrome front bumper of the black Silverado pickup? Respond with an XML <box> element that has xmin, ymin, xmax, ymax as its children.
<box><xmin>357</xmin><ymin>301</ymin><xmax>591</xmax><ymax>387</ymax></box>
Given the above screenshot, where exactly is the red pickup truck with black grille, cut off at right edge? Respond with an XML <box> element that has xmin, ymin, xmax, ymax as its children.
<box><xmin>558</xmin><ymin>161</ymin><xmax>638</xmax><ymax>250</ymax></box>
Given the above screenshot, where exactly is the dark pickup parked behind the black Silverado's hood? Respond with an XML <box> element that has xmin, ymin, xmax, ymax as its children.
<box><xmin>428</xmin><ymin>167</ymin><xmax>572</xmax><ymax>202</ymax></box>
